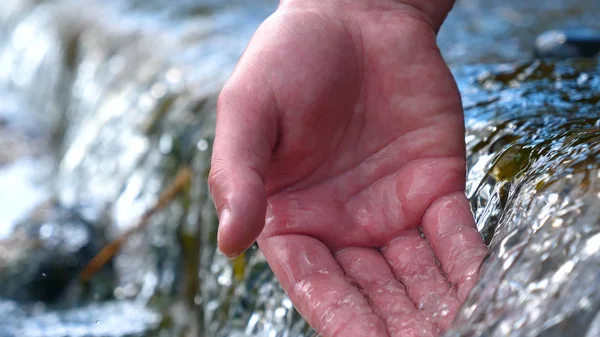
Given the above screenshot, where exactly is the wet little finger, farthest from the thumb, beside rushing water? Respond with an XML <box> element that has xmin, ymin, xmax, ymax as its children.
<box><xmin>422</xmin><ymin>192</ymin><xmax>487</xmax><ymax>301</ymax></box>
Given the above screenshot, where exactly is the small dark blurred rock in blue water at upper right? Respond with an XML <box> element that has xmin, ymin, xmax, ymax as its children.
<box><xmin>534</xmin><ymin>28</ymin><xmax>600</xmax><ymax>59</ymax></box>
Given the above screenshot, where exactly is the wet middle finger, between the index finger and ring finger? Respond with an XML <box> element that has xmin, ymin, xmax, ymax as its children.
<box><xmin>335</xmin><ymin>247</ymin><xmax>439</xmax><ymax>337</ymax></box>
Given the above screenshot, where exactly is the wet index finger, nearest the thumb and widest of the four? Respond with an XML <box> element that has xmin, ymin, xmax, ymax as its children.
<box><xmin>258</xmin><ymin>235</ymin><xmax>389</xmax><ymax>337</ymax></box>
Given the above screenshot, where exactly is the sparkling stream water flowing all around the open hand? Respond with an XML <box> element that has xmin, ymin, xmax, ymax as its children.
<box><xmin>0</xmin><ymin>0</ymin><xmax>600</xmax><ymax>337</ymax></box>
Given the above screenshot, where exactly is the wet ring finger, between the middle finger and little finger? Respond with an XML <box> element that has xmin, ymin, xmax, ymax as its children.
<box><xmin>382</xmin><ymin>230</ymin><xmax>460</xmax><ymax>330</ymax></box>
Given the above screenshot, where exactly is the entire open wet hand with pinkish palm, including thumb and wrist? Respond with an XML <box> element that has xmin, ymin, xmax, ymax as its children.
<box><xmin>209</xmin><ymin>0</ymin><xmax>486</xmax><ymax>337</ymax></box>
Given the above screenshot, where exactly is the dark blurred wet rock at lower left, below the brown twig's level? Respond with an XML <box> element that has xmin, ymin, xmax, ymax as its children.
<box><xmin>0</xmin><ymin>202</ymin><xmax>112</xmax><ymax>305</ymax></box>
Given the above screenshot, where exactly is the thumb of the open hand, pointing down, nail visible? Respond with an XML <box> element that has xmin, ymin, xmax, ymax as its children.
<box><xmin>208</xmin><ymin>79</ymin><xmax>277</xmax><ymax>258</ymax></box>
